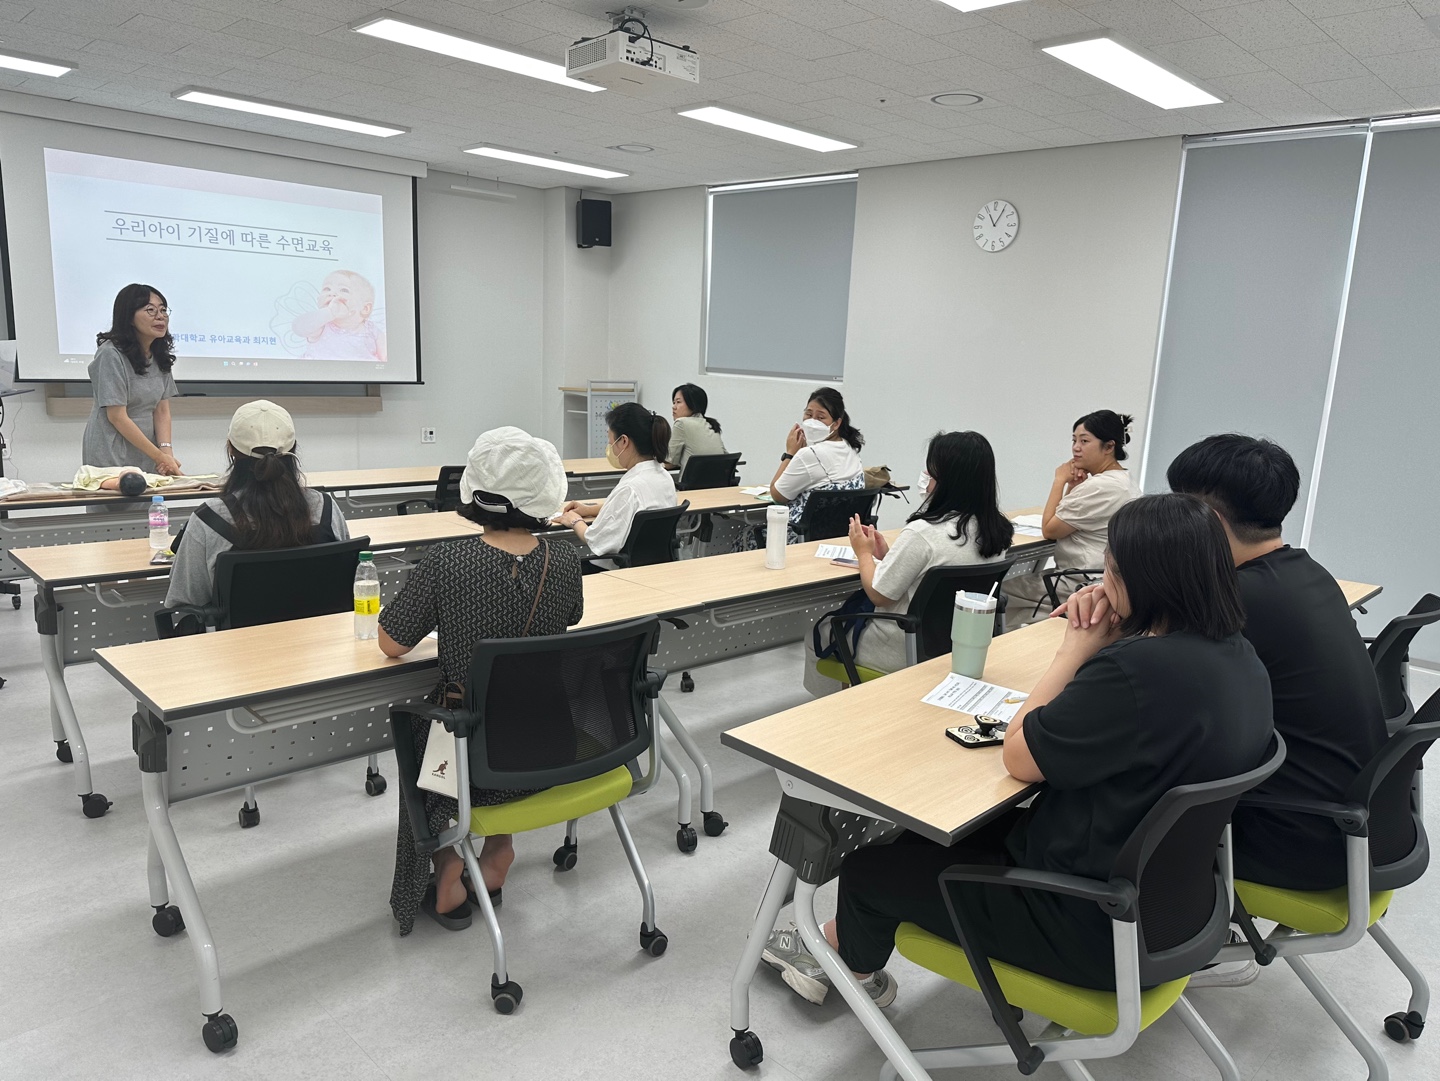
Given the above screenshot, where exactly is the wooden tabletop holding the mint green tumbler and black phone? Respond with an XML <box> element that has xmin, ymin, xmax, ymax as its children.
<box><xmin>720</xmin><ymin>619</ymin><xmax>1066</xmax><ymax>845</ymax></box>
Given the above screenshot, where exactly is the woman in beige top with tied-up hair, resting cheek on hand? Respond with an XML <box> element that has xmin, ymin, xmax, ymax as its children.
<box><xmin>1004</xmin><ymin>409</ymin><xmax>1140</xmax><ymax>626</ymax></box>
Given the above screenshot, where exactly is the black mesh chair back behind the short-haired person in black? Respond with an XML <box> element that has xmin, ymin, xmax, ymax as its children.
<box><xmin>1345</xmin><ymin>691</ymin><xmax>1440</xmax><ymax>891</ymax></box>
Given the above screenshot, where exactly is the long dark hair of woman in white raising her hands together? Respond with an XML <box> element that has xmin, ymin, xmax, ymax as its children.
<box><xmin>906</xmin><ymin>432</ymin><xmax>1015</xmax><ymax>560</ymax></box>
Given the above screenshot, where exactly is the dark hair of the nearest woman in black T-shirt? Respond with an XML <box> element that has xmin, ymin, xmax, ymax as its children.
<box><xmin>1109</xmin><ymin>492</ymin><xmax>1246</xmax><ymax>639</ymax></box>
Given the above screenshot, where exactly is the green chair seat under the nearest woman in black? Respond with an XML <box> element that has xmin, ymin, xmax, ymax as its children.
<box><xmin>896</xmin><ymin>923</ymin><xmax>1189</xmax><ymax>1036</ymax></box>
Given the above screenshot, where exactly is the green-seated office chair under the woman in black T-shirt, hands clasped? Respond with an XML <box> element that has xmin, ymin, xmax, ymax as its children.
<box><xmin>881</xmin><ymin>733</ymin><xmax>1284</xmax><ymax>1081</ymax></box>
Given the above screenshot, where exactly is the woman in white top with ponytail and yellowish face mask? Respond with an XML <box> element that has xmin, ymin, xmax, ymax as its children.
<box><xmin>556</xmin><ymin>402</ymin><xmax>675</xmax><ymax>573</ymax></box>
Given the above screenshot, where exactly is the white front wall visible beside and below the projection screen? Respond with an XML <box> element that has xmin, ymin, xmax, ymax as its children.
<box><xmin>6</xmin><ymin>173</ymin><xmax>544</xmax><ymax>481</ymax></box>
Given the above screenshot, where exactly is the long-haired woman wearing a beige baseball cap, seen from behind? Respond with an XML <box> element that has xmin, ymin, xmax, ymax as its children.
<box><xmin>166</xmin><ymin>399</ymin><xmax>350</xmax><ymax>607</ymax></box>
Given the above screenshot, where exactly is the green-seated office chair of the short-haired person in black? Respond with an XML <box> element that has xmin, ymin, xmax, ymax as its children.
<box><xmin>1217</xmin><ymin>691</ymin><xmax>1440</xmax><ymax>1081</ymax></box>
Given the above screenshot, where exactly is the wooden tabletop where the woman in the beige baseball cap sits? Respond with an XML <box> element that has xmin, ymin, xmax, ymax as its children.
<box><xmin>10</xmin><ymin>511</ymin><xmax>481</xmax><ymax>587</ymax></box>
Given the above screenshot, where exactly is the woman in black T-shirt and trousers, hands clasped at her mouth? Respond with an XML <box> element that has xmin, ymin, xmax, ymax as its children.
<box><xmin>766</xmin><ymin>494</ymin><xmax>1273</xmax><ymax>1006</ymax></box>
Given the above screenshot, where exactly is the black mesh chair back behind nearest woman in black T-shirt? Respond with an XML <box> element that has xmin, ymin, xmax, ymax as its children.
<box><xmin>1110</xmin><ymin>733</ymin><xmax>1284</xmax><ymax>987</ymax></box>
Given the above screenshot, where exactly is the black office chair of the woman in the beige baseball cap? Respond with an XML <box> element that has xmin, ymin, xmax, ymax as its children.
<box><xmin>156</xmin><ymin>537</ymin><xmax>386</xmax><ymax>829</ymax></box>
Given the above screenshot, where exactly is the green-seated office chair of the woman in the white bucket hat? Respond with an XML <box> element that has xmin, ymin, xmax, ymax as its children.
<box><xmin>390</xmin><ymin>618</ymin><xmax>668</xmax><ymax>1013</ymax></box>
